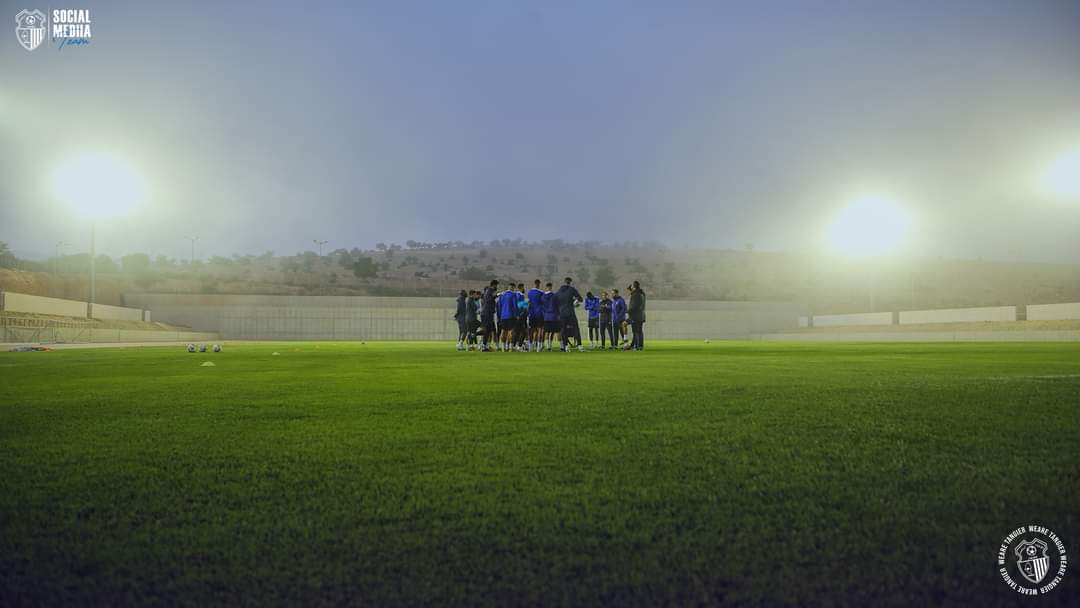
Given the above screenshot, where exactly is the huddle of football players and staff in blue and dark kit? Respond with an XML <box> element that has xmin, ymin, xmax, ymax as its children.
<box><xmin>454</xmin><ymin>276</ymin><xmax>644</xmax><ymax>352</ymax></box>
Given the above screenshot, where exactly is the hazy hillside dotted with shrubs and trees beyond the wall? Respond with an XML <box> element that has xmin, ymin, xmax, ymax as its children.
<box><xmin>0</xmin><ymin>239</ymin><xmax>1080</xmax><ymax>313</ymax></box>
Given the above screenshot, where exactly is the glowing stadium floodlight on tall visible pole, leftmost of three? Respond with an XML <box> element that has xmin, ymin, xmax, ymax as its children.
<box><xmin>52</xmin><ymin>151</ymin><xmax>143</xmax><ymax>317</ymax></box>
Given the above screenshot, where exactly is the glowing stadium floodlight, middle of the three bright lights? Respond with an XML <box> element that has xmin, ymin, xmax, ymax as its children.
<box><xmin>825</xmin><ymin>194</ymin><xmax>912</xmax><ymax>312</ymax></box>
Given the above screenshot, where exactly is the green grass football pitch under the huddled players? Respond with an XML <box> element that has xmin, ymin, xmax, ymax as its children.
<box><xmin>0</xmin><ymin>342</ymin><xmax>1080</xmax><ymax>606</ymax></box>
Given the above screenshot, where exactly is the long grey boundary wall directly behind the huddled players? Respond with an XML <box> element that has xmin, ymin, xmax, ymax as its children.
<box><xmin>124</xmin><ymin>294</ymin><xmax>801</xmax><ymax>340</ymax></box>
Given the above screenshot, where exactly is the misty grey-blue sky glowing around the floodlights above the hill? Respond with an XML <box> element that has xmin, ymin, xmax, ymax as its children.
<box><xmin>0</xmin><ymin>0</ymin><xmax>1080</xmax><ymax>262</ymax></box>
